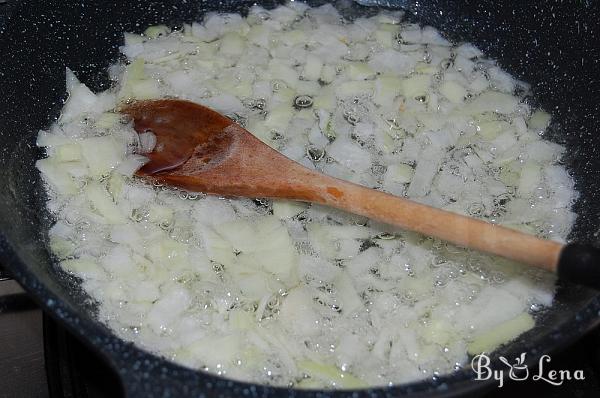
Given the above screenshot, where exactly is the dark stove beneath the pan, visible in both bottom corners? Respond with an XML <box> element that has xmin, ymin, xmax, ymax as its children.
<box><xmin>0</xmin><ymin>267</ymin><xmax>600</xmax><ymax>398</ymax></box>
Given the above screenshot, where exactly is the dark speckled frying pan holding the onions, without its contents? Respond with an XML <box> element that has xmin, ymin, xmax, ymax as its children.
<box><xmin>0</xmin><ymin>0</ymin><xmax>600</xmax><ymax>397</ymax></box>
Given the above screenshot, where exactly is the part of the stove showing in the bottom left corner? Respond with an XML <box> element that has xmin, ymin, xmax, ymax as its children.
<box><xmin>0</xmin><ymin>267</ymin><xmax>123</xmax><ymax>398</ymax></box>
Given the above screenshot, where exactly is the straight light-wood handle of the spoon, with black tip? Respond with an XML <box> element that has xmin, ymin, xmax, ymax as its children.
<box><xmin>302</xmin><ymin>174</ymin><xmax>600</xmax><ymax>289</ymax></box>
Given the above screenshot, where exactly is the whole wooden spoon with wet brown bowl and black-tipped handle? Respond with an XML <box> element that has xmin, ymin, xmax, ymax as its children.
<box><xmin>120</xmin><ymin>99</ymin><xmax>600</xmax><ymax>287</ymax></box>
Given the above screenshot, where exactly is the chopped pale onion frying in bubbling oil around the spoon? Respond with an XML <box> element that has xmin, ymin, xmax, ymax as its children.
<box><xmin>36</xmin><ymin>1</ymin><xmax>577</xmax><ymax>388</ymax></box>
